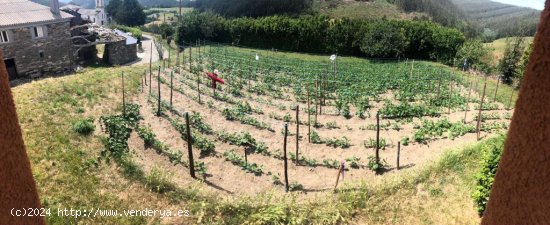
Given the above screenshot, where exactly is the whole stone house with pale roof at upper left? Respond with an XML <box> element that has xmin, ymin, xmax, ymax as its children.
<box><xmin>0</xmin><ymin>0</ymin><xmax>74</xmax><ymax>80</ymax></box>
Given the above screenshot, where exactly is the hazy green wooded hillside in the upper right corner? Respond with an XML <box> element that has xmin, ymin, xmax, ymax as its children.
<box><xmin>452</xmin><ymin>0</ymin><xmax>541</xmax><ymax>40</ymax></box>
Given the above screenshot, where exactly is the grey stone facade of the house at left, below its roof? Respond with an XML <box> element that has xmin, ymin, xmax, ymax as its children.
<box><xmin>0</xmin><ymin>21</ymin><xmax>73</xmax><ymax>78</ymax></box>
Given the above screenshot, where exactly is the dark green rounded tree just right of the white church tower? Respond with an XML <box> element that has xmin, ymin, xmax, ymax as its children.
<box><xmin>114</xmin><ymin>0</ymin><xmax>146</xmax><ymax>26</ymax></box>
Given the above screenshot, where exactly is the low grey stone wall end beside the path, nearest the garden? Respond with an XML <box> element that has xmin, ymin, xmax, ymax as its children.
<box><xmin>103</xmin><ymin>39</ymin><xmax>137</xmax><ymax>65</ymax></box>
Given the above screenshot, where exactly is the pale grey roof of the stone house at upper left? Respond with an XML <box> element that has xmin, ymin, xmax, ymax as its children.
<box><xmin>0</xmin><ymin>0</ymin><xmax>74</xmax><ymax>27</ymax></box>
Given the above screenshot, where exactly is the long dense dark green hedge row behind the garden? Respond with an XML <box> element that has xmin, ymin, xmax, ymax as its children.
<box><xmin>175</xmin><ymin>11</ymin><xmax>465</xmax><ymax>62</ymax></box>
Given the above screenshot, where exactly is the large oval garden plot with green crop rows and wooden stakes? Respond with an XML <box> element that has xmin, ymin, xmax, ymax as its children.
<box><xmin>124</xmin><ymin>44</ymin><xmax>512</xmax><ymax>194</ymax></box>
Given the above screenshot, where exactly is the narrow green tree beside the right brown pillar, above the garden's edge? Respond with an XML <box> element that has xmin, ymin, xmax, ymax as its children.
<box><xmin>499</xmin><ymin>38</ymin><xmax>524</xmax><ymax>84</ymax></box>
